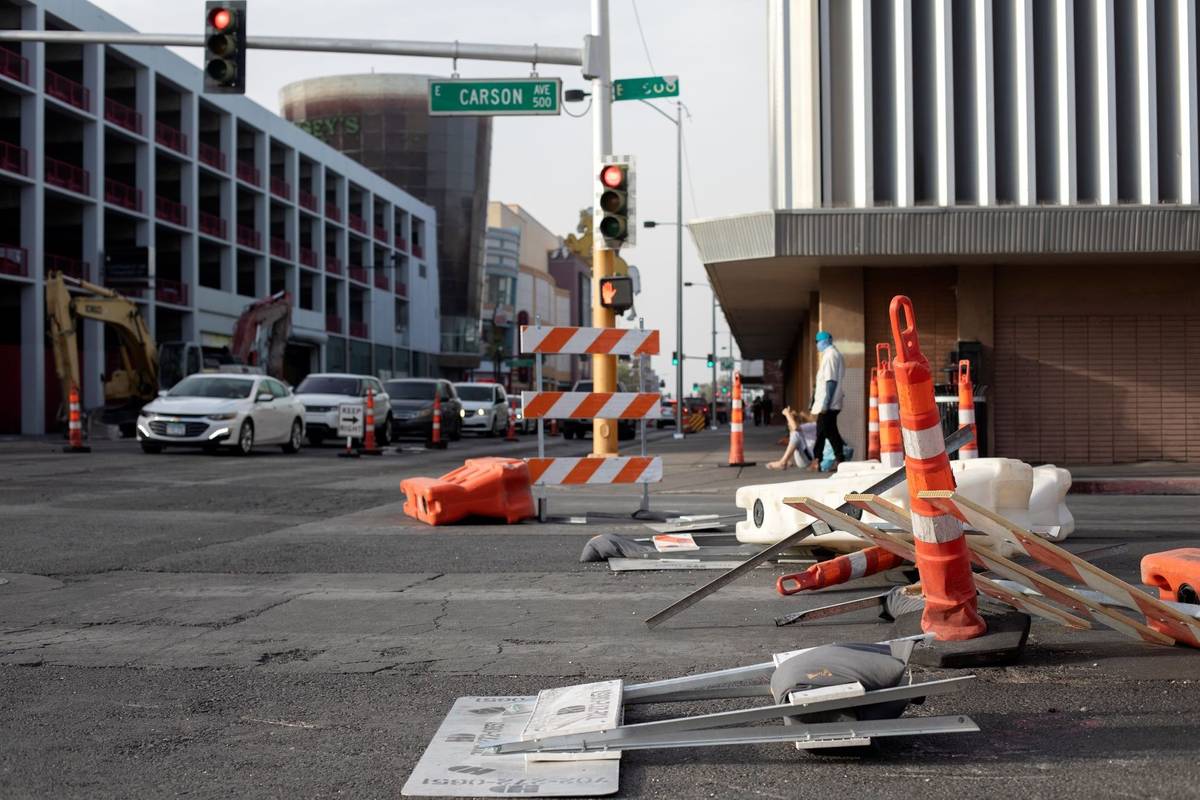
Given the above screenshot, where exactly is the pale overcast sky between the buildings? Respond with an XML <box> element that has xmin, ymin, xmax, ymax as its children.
<box><xmin>92</xmin><ymin>0</ymin><xmax>768</xmax><ymax>391</ymax></box>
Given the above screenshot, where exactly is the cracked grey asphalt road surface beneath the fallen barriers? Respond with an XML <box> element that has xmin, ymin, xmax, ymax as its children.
<box><xmin>0</xmin><ymin>431</ymin><xmax>1200</xmax><ymax>799</ymax></box>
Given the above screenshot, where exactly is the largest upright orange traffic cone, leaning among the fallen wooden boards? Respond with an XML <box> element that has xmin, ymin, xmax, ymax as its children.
<box><xmin>890</xmin><ymin>295</ymin><xmax>988</xmax><ymax>642</ymax></box>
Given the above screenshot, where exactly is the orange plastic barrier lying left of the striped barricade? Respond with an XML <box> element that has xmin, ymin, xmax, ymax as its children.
<box><xmin>400</xmin><ymin>458</ymin><xmax>538</xmax><ymax>525</ymax></box>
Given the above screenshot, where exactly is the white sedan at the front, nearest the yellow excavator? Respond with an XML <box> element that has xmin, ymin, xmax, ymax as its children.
<box><xmin>137</xmin><ymin>373</ymin><xmax>305</xmax><ymax>456</ymax></box>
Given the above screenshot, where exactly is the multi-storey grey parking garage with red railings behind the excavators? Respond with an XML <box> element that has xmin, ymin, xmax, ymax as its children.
<box><xmin>0</xmin><ymin>0</ymin><xmax>440</xmax><ymax>434</ymax></box>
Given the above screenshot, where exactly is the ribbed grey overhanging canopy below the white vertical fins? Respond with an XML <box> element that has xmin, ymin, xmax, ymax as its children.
<box><xmin>688</xmin><ymin>205</ymin><xmax>1200</xmax><ymax>359</ymax></box>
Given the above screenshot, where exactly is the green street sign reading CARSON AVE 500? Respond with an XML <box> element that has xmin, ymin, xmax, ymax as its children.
<box><xmin>430</xmin><ymin>78</ymin><xmax>563</xmax><ymax>116</ymax></box>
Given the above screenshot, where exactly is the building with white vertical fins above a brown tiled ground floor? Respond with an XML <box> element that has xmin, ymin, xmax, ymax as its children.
<box><xmin>690</xmin><ymin>0</ymin><xmax>1200</xmax><ymax>464</ymax></box>
